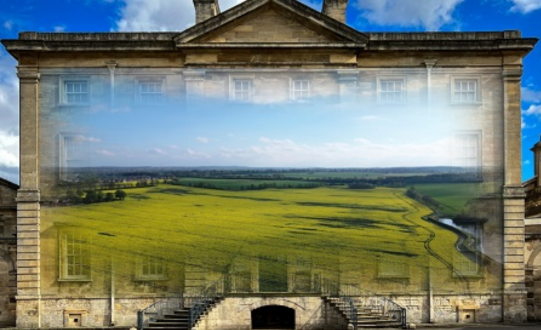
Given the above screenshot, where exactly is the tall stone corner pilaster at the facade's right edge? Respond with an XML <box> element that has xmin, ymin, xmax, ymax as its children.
<box><xmin>503</xmin><ymin>63</ymin><xmax>527</xmax><ymax>322</ymax></box>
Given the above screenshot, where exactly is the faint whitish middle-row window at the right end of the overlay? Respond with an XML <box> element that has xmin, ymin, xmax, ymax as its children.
<box><xmin>453</xmin><ymin>132</ymin><xmax>481</xmax><ymax>173</ymax></box>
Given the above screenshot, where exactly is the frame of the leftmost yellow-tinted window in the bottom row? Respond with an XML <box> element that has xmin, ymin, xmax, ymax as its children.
<box><xmin>58</xmin><ymin>230</ymin><xmax>92</xmax><ymax>282</ymax></box>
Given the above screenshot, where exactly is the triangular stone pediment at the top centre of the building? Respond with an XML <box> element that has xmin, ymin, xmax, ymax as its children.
<box><xmin>175</xmin><ymin>0</ymin><xmax>368</xmax><ymax>47</ymax></box>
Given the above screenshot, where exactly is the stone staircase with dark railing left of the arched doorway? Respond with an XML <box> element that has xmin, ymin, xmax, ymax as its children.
<box><xmin>143</xmin><ymin>298</ymin><xmax>221</xmax><ymax>330</ymax></box>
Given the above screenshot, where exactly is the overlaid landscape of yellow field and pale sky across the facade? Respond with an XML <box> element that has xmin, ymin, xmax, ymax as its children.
<box><xmin>40</xmin><ymin>70</ymin><xmax>502</xmax><ymax>324</ymax></box>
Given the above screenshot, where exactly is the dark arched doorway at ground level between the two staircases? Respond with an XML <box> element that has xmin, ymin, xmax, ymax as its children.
<box><xmin>252</xmin><ymin>305</ymin><xmax>295</xmax><ymax>329</ymax></box>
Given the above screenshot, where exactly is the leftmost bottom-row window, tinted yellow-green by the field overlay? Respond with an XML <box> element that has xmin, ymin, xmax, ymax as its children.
<box><xmin>60</xmin><ymin>233</ymin><xmax>90</xmax><ymax>281</ymax></box>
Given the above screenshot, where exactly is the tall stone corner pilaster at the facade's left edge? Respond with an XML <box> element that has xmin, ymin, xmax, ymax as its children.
<box><xmin>16</xmin><ymin>66</ymin><xmax>41</xmax><ymax>328</ymax></box>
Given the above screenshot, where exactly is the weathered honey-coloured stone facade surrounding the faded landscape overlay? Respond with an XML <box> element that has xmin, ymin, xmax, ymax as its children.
<box><xmin>2</xmin><ymin>0</ymin><xmax>537</xmax><ymax>329</ymax></box>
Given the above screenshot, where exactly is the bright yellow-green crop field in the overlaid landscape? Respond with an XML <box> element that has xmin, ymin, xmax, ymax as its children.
<box><xmin>42</xmin><ymin>184</ymin><xmax>490</xmax><ymax>292</ymax></box>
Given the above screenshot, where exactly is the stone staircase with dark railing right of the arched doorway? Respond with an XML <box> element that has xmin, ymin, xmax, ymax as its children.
<box><xmin>325</xmin><ymin>297</ymin><xmax>405</xmax><ymax>329</ymax></box>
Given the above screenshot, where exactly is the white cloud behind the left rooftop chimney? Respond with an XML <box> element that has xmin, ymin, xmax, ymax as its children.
<box><xmin>114</xmin><ymin>0</ymin><xmax>248</xmax><ymax>31</ymax></box>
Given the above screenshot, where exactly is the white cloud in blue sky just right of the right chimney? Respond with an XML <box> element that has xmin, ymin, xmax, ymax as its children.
<box><xmin>355</xmin><ymin>0</ymin><xmax>462</xmax><ymax>30</ymax></box>
